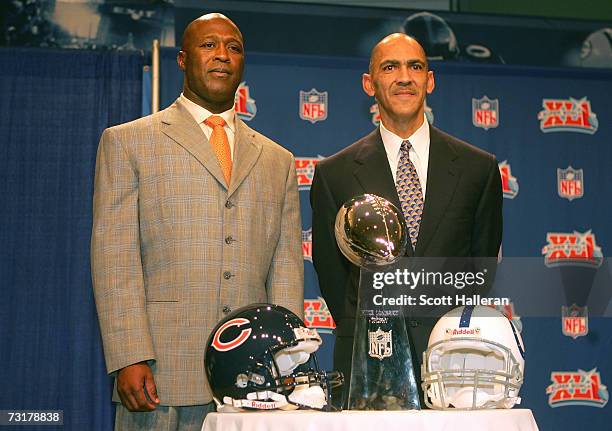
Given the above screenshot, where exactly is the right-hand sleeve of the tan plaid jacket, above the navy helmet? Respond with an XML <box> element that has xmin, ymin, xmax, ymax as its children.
<box><xmin>262</xmin><ymin>156</ymin><xmax>304</xmax><ymax>319</ymax></box>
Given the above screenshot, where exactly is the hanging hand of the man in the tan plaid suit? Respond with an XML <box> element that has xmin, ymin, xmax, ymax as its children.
<box><xmin>117</xmin><ymin>362</ymin><xmax>159</xmax><ymax>412</ymax></box>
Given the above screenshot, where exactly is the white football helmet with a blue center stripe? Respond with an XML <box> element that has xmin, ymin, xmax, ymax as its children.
<box><xmin>421</xmin><ymin>306</ymin><xmax>525</xmax><ymax>410</ymax></box>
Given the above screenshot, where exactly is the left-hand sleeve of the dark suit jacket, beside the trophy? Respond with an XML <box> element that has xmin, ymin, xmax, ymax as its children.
<box><xmin>310</xmin><ymin>165</ymin><xmax>352</xmax><ymax>322</ymax></box>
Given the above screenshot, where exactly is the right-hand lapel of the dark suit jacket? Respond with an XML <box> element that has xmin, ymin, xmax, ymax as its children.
<box><xmin>415</xmin><ymin>126</ymin><xmax>460</xmax><ymax>256</ymax></box>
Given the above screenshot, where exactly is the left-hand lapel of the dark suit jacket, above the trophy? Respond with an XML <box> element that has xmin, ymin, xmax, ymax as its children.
<box><xmin>353</xmin><ymin>129</ymin><xmax>413</xmax><ymax>256</ymax></box>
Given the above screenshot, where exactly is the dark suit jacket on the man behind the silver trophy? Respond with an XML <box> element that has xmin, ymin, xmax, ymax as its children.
<box><xmin>310</xmin><ymin>126</ymin><xmax>503</xmax><ymax>404</ymax></box>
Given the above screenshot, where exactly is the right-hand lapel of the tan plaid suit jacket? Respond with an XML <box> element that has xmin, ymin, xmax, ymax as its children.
<box><xmin>228</xmin><ymin>117</ymin><xmax>262</xmax><ymax>197</ymax></box>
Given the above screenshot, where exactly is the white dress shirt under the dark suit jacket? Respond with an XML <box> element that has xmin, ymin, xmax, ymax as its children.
<box><xmin>380</xmin><ymin>116</ymin><xmax>429</xmax><ymax>202</ymax></box>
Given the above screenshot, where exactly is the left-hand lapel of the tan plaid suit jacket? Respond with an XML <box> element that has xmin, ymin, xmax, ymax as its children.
<box><xmin>162</xmin><ymin>102</ymin><xmax>227</xmax><ymax>188</ymax></box>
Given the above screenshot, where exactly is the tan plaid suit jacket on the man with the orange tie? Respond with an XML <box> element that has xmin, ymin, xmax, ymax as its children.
<box><xmin>91</xmin><ymin>101</ymin><xmax>304</xmax><ymax>406</ymax></box>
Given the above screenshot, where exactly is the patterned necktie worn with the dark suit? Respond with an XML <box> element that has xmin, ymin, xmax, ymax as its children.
<box><xmin>395</xmin><ymin>140</ymin><xmax>423</xmax><ymax>249</ymax></box>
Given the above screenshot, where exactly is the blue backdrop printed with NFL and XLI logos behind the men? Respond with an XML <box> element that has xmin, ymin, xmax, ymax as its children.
<box><xmin>161</xmin><ymin>49</ymin><xmax>612</xmax><ymax>430</ymax></box>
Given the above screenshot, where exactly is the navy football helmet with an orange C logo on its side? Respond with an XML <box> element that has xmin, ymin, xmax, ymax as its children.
<box><xmin>204</xmin><ymin>304</ymin><xmax>343</xmax><ymax>412</ymax></box>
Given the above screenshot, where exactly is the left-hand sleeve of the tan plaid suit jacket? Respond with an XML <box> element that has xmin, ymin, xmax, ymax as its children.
<box><xmin>91</xmin><ymin>129</ymin><xmax>155</xmax><ymax>373</ymax></box>
